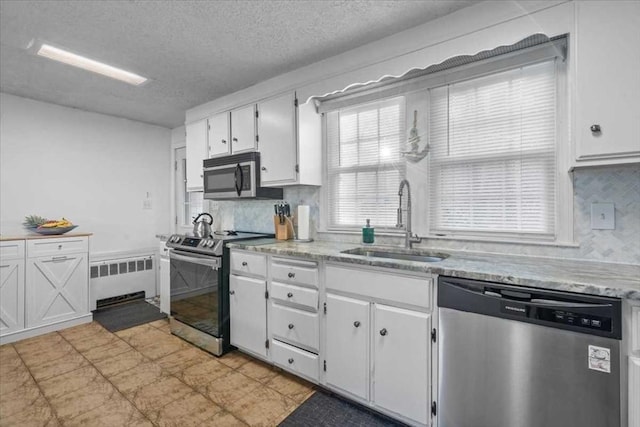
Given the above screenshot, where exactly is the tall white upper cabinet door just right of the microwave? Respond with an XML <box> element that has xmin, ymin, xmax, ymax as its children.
<box><xmin>258</xmin><ymin>93</ymin><xmax>298</xmax><ymax>186</ymax></box>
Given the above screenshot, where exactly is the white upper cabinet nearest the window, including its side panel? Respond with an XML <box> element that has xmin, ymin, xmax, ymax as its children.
<box><xmin>257</xmin><ymin>93</ymin><xmax>322</xmax><ymax>187</ymax></box>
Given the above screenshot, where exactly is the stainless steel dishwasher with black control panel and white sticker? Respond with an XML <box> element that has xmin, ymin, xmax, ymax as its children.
<box><xmin>437</xmin><ymin>277</ymin><xmax>622</xmax><ymax>427</ymax></box>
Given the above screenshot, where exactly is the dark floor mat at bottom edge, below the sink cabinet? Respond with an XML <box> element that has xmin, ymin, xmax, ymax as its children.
<box><xmin>279</xmin><ymin>390</ymin><xmax>405</xmax><ymax>427</ymax></box>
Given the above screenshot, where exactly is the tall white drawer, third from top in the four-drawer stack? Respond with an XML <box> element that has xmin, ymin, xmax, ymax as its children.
<box><xmin>269</xmin><ymin>302</ymin><xmax>320</xmax><ymax>351</ymax></box>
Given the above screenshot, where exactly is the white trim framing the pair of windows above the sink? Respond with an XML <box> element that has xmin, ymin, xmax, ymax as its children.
<box><xmin>319</xmin><ymin>40</ymin><xmax>576</xmax><ymax>247</ymax></box>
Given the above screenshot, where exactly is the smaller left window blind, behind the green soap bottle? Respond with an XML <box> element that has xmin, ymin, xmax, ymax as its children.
<box><xmin>326</xmin><ymin>97</ymin><xmax>405</xmax><ymax>229</ymax></box>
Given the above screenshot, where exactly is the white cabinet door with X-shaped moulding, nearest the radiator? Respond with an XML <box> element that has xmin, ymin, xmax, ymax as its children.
<box><xmin>26</xmin><ymin>253</ymin><xmax>89</xmax><ymax>327</ymax></box>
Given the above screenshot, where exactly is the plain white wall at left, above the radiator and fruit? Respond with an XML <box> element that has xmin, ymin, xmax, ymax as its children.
<box><xmin>0</xmin><ymin>93</ymin><xmax>171</xmax><ymax>256</ymax></box>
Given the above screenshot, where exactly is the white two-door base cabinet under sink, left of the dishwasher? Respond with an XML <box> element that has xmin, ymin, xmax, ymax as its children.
<box><xmin>324</xmin><ymin>265</ymin><xmax>432</xmax><ymax>426</ymax></box>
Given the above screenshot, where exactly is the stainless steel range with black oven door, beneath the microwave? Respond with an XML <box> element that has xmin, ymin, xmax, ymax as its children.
<box><xmin>167</xmin><ymin>231</ymin><xmax>272</xmax><ymax>356</ymax></box>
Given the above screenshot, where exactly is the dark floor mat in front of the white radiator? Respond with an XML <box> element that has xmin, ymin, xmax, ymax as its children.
<box><xmin>93</xmin><ymin>300</ymin><xmax>167</xmax><ymax>332</ymax></box>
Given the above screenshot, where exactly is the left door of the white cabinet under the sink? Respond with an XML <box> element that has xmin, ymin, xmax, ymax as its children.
<box><xmin>325</xmin><ymin>293</ymin><xmax>370</xmax><ymax>400</ymax></box>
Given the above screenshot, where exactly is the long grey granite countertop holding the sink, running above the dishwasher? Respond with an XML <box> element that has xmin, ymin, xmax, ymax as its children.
<box><xmin>227</xmin><ymin>239</ymin><xmax>640</xmax><ymax>300</ymax></box>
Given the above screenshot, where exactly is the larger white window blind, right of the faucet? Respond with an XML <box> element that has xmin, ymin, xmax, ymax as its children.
<box><xmin>429</xmin><ymin>60</ymin><xmax>557</xmax><ymax>238</ymax></box>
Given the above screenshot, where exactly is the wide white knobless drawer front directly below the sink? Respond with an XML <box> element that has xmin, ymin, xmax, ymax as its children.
<box><xmin>325</xmin><ymin>265</ymin><xmax>433</xmax><ymax>308</ymax></box>
